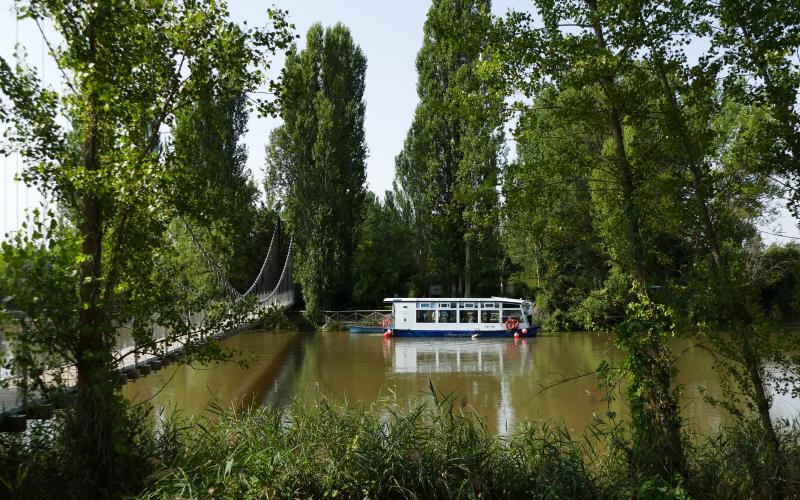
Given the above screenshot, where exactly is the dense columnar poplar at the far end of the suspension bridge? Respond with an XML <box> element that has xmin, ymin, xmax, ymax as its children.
<box><xmin>266</xmin><ymin>24</ymin><xmax>367</xmax><ymax>317</ymax></box>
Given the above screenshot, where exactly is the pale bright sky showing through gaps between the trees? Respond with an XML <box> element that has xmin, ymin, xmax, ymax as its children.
<box><xmin>0</xmin><ymin>0</ymin><xmax>800</xmax><ymax>241</ymax></box>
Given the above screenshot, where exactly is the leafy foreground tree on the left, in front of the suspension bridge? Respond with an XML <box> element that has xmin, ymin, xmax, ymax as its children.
<box><xmin>0</xmin><ymin>0</ymin><xmax>288</xmax><ymax>498</ymax></box>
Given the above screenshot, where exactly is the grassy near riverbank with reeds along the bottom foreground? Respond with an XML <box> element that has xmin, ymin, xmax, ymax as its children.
<box><xmin>6</xmin><ymin>395</ymin><xmax>800</xmax><ymax>499</ymax></box>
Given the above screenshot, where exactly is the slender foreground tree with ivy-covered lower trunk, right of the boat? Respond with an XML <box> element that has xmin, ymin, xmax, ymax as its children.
<box><xmin>505</xmin><ymin>0</ymin><xmax>685</xmax><ymax>474</ymax></box>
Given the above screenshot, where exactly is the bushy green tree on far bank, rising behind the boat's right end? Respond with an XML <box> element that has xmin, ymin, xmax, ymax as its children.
<box><xmin>503</xmin><ymin>85</ymin><xmax>612</xmax><ymax>329</ymax></box>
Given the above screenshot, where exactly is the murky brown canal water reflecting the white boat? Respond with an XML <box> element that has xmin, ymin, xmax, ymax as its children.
<box><xmin>123</xmin><ymin>331</ymin><xmax>800</xmax><ymax>434</ymax></box>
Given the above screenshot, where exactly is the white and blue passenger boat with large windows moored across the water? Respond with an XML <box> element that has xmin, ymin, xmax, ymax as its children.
<box><xmin>383</xmin><ymin>297</ymin><xmax>539</xmax><ymax>338</ymax></box>
